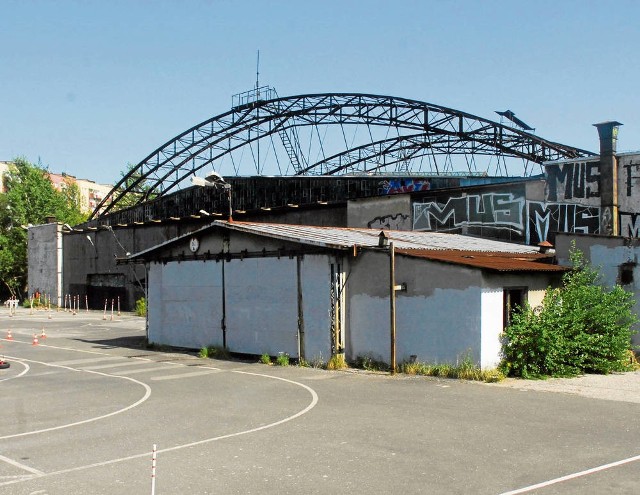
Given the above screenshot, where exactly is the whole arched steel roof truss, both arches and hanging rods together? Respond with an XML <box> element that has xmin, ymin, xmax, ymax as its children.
<box><xmin>92</xmin><ymin>94</ymin><xmax>593</xmax><ymax>218</ymax></box>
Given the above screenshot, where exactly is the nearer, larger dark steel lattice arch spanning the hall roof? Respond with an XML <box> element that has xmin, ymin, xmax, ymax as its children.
<box><xmin>91</xmin><ymin>93</ymin><xmax>593</xmax><ymax>218</ymax></box>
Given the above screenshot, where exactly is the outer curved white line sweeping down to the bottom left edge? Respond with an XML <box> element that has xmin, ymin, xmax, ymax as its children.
<box><xmin>0</xmin><ymin>371</ymin><xmax>318</xmax><ymax>486</ymax></box>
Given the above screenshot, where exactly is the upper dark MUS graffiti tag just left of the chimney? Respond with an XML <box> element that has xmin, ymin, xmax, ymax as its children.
<box><xmin>546</xmin><ymin>162</ymin><xmax>600</xmax><ymax>202</ymax></box>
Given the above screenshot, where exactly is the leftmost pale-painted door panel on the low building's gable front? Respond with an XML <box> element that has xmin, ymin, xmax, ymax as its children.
<box><xmin>148</xmin><ymin>261</ymin><xmax>222</xmax><ymax>349</ymax></box>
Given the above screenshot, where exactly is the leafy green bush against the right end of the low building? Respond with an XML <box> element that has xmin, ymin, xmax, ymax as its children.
<box><xmin>501</xmin><ymin>245</ymin><xmax>637</xmax><ymax>378</ymax></box>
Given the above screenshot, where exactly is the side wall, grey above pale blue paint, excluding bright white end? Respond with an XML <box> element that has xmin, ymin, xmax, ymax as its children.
<box><xmin>347</xmin><ymin>252</ymin><xmax>482</xmax><ymax>363</ymax></box>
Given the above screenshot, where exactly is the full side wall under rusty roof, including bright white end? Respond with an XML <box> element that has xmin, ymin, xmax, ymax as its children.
<box><xmin>347</xmin><ymin>252</ymin><xmax>558</xmax><ymax>368</ymax></box>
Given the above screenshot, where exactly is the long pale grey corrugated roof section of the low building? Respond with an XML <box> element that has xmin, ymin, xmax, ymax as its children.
<box><xmin>219</xmin><ymin>220</ymin><xmax>538</xmax><ymax>253</ymax></box>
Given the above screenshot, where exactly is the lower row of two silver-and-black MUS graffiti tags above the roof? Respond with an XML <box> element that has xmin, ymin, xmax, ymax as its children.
<box><xmin>413</xmin><ymin>193</ymin><xmax>600</xmax><ymax>244</ymax></box>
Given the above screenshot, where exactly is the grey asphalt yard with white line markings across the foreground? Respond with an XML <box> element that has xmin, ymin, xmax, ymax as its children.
<box><xmin>0</xmin><ymin>309</ymin><xmax>640</xmax><ymax>495</ymax></box>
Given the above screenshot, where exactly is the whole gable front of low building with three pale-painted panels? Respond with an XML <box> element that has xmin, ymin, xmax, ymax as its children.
<box><xmin>148</xmin><ymin>230</ymin><xmax>331</xmax><ymax>361</ymax></box>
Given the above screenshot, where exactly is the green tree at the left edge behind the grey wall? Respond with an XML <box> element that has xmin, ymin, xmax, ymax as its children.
<box><xmin>0</xmin><ymin>158</ymin><xmax>86</xmax><ymax>296</ymax></box>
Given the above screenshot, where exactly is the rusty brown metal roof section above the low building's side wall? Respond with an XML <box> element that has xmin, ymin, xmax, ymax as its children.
<box><xmin>396</xmin><ymin>249</ymin><xmax>567</xmax><ymax>272</ymax></box>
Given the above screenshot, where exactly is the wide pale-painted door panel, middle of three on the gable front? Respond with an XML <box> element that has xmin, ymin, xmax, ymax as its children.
<box><xmin>225</xmin><ymin>257</ymin><xmax>298</xmax><ymax>358</ymax></box>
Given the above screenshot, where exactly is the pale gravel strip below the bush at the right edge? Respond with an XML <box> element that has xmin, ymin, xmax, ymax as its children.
<box><xmin>492</xmin><ymin>371</ymin><xmax>640</xmax><ymax>404</ymax></box>
